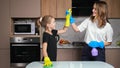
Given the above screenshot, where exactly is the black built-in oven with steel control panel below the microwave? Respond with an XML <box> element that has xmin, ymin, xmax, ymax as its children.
<box><xmin>10</xmin><ymin>37</ymin><xmax>41</xmax><ymax>68</ymax></box>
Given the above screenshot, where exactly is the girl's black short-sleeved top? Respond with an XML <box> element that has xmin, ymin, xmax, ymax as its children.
<box><xmin>43</xmin><ymin>30</ymin><xmax>58</xmax><ymax>61</ymax></box>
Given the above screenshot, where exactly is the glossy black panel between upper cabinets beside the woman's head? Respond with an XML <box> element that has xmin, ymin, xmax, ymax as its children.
<box><xmin>72</xmin><ymin>0</ymin><xmax>99</xmax><ymax>17</ymax></box>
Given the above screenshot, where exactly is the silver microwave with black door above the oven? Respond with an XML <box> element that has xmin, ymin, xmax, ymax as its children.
<box><xmin>13</xmin><ymin>23</ymin><xmax>35</xmax><ymax>34</ymax></box>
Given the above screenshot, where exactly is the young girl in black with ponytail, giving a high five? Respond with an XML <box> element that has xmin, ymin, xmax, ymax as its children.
<box><xmin>40</xmin><ymin>15</ymin><xmax>67</xmax><ymax>65</ymax></box>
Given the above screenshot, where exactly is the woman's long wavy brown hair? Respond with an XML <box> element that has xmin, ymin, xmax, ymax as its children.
<box><xmin>90</xmin><ymin>1</ymin><xmax>108</xmax><ymax>28</ymax></box>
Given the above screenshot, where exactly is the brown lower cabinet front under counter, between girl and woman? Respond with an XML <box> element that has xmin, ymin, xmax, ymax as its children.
<box><xmin>57</xmin><ymin>48</ymin><xmax>81</xmax><ymax>61</ymax></box>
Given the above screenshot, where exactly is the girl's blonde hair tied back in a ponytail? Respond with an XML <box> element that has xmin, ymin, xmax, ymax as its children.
<box><xmin>40</xmin><ymin>15</ymin><xmax>54</xmax><ymax>28</ymax></box>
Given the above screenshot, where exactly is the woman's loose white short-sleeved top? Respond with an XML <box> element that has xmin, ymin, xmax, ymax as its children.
<box><xmin>78</xmin><ymin>18</ymin><xmax>113</xmax><ymax>43</ymax></box>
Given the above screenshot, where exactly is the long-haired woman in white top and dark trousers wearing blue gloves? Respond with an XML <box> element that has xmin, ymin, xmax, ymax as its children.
<box><xmin>71</xmin><ymin>1</ymin><xmax>113</xmax><ymax>62</ymax></box>
